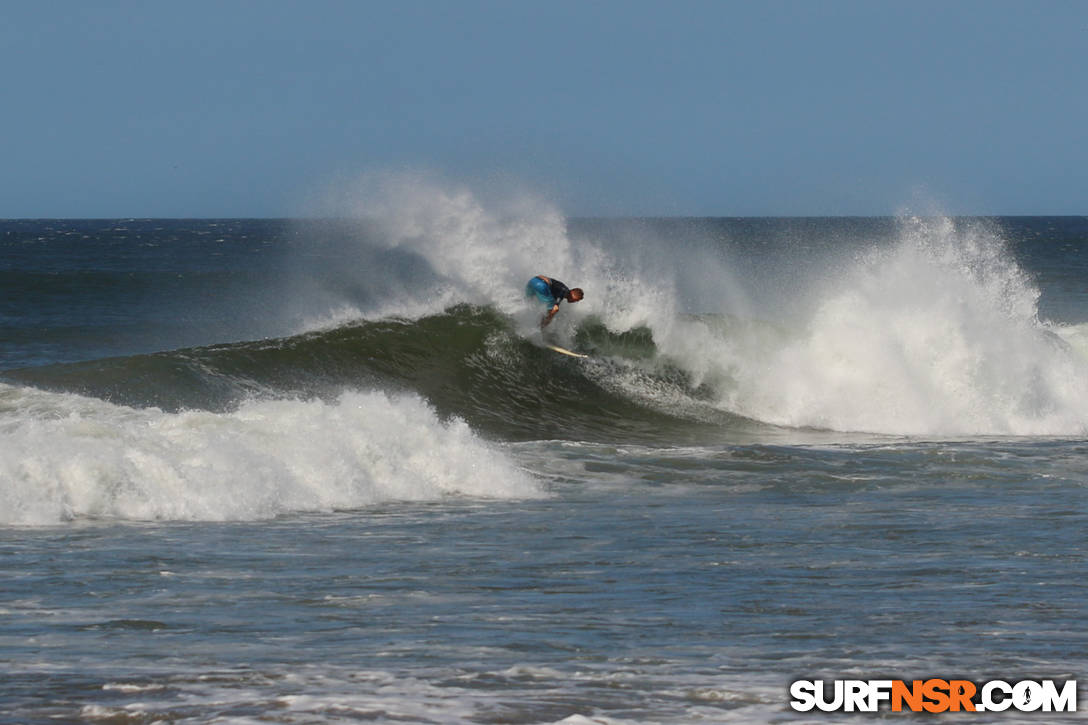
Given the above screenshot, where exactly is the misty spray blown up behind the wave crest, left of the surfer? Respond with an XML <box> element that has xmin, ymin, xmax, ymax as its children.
<box><xmin>295</xmin><ymin>172</ymin><xmax>578</xmax><ymax>329</ymax></box>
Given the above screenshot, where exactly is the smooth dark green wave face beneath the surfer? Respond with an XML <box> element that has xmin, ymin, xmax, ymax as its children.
<box><xmin>5</xmin><ymin>305</ymin><xmax>756</xmax><ymax>443</ymax></box>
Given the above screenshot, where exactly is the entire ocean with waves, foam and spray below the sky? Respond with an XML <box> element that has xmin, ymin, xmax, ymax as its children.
<box><xmin>0</xmin><ymin>185</ymin><xmax>1088</xmax><ymax>725</ymax></box>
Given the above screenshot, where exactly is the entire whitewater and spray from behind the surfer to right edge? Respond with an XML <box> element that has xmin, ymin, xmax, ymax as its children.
<box><xmin>289</xmin><ymin>176</ymin><xmax>1088</xmax><ymax>435</ymax></box>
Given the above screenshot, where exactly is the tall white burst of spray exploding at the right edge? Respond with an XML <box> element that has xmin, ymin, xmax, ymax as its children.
<box><xmin>722</xmin><ymin>212</ymin><xmax>1088</xmax><ymax>435</ymax></box>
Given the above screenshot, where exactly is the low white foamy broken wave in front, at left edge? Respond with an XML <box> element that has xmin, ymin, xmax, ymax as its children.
<box><xmin>0</xmin><ymin>385</ymin><xmax>540</xmax><ymax>525</ymax></box>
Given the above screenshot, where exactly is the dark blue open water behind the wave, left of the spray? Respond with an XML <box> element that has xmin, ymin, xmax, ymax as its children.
<box><xmin>0</xmin><ymin>220</ymin><xmax>290</xmax><ymax>368</ymax></box>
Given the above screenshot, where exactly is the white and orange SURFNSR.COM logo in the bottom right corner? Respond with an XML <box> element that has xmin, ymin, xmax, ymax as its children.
<box><xmin>790</xmin><ymin>678</ymin><xmax>1077</xmax><ymax>712</ymax></box>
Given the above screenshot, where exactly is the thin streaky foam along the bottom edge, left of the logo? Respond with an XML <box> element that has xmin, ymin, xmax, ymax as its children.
<box><xmin>81</xmin><ymin>662</ymin><xmax>782</xmax><ymax>725</ymax></box>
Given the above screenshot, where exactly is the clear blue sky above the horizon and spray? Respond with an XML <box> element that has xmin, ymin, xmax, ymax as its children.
<box><xmin>0</xmin><ymin>0</ymin><xmax>1088</xmax><ymax>218</ymax></box>
